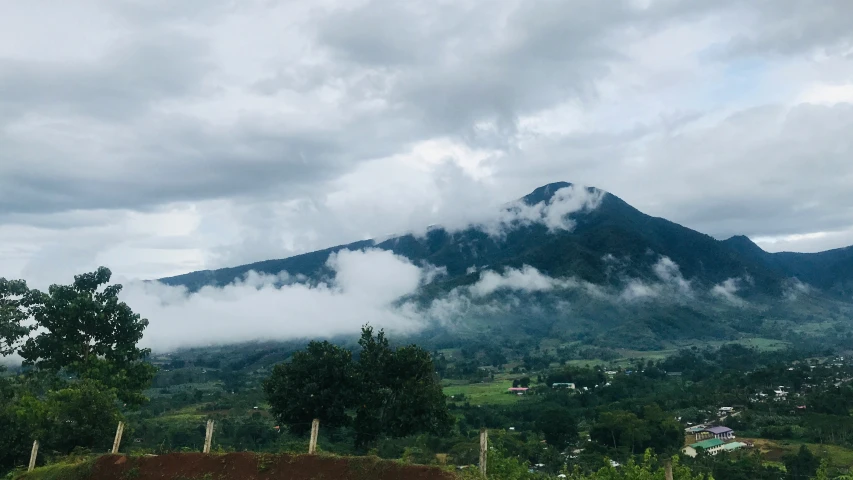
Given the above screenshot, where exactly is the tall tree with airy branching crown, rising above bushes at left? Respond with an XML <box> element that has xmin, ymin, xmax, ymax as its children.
<box><xmin>20</xmin><ymin>267</ymin><xmax>155</xmax><ymax>404</ymax></box>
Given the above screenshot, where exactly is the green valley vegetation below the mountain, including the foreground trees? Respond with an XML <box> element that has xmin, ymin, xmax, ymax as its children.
<box><xmin>5</xmin><ymin>269</ymin><xmax>853</xmax><ymax>480</ymax></box>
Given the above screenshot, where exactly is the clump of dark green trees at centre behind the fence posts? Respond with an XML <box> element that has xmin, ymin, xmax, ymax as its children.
<box><xmin>264</xmin><ymin>326</ymin><xmax>453</xmax><ymax>447</ymax></box>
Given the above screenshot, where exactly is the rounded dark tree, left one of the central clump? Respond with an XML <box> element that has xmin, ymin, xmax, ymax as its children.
<box><xmin>263</xmin><ymin>342</ymin><xmax>356</xmax><ymax>434</ymax></box>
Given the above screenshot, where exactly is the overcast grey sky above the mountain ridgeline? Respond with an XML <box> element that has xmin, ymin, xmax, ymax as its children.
<box><xmin>0</xmin><ymin>0</ymin><xmax>853</xmax><ymax>285</ymax></box>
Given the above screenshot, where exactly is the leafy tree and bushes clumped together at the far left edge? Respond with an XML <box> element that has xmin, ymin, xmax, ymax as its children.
<box><xmin>0</xmin><ymin>267</ymin><xmax>155</xmax><ymax>470</ymax></box>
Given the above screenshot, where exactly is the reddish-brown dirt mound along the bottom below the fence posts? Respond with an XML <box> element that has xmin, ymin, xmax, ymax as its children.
<box><xmin>85</xmin><ymin>453</ymin><xmax>456</xmax><ymax>480</ymax></box>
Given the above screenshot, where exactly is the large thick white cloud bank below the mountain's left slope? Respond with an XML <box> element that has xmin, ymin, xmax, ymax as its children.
<box><xmin>122</xmin><ymin>250</ymin><xmax>432</xmax><ymax>350</ymax></box>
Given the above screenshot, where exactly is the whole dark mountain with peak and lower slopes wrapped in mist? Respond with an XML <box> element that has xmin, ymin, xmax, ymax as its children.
<box><xmin>160</xmin><ymin>182</ymin><xmax>853</xmax><ymax>348</ymax></box>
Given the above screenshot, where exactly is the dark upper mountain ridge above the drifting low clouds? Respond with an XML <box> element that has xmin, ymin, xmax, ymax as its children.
<box><xmin>159</xmin><ymin>182</ymin><xmax>853</xmax><ymax>296</ymax></box>
